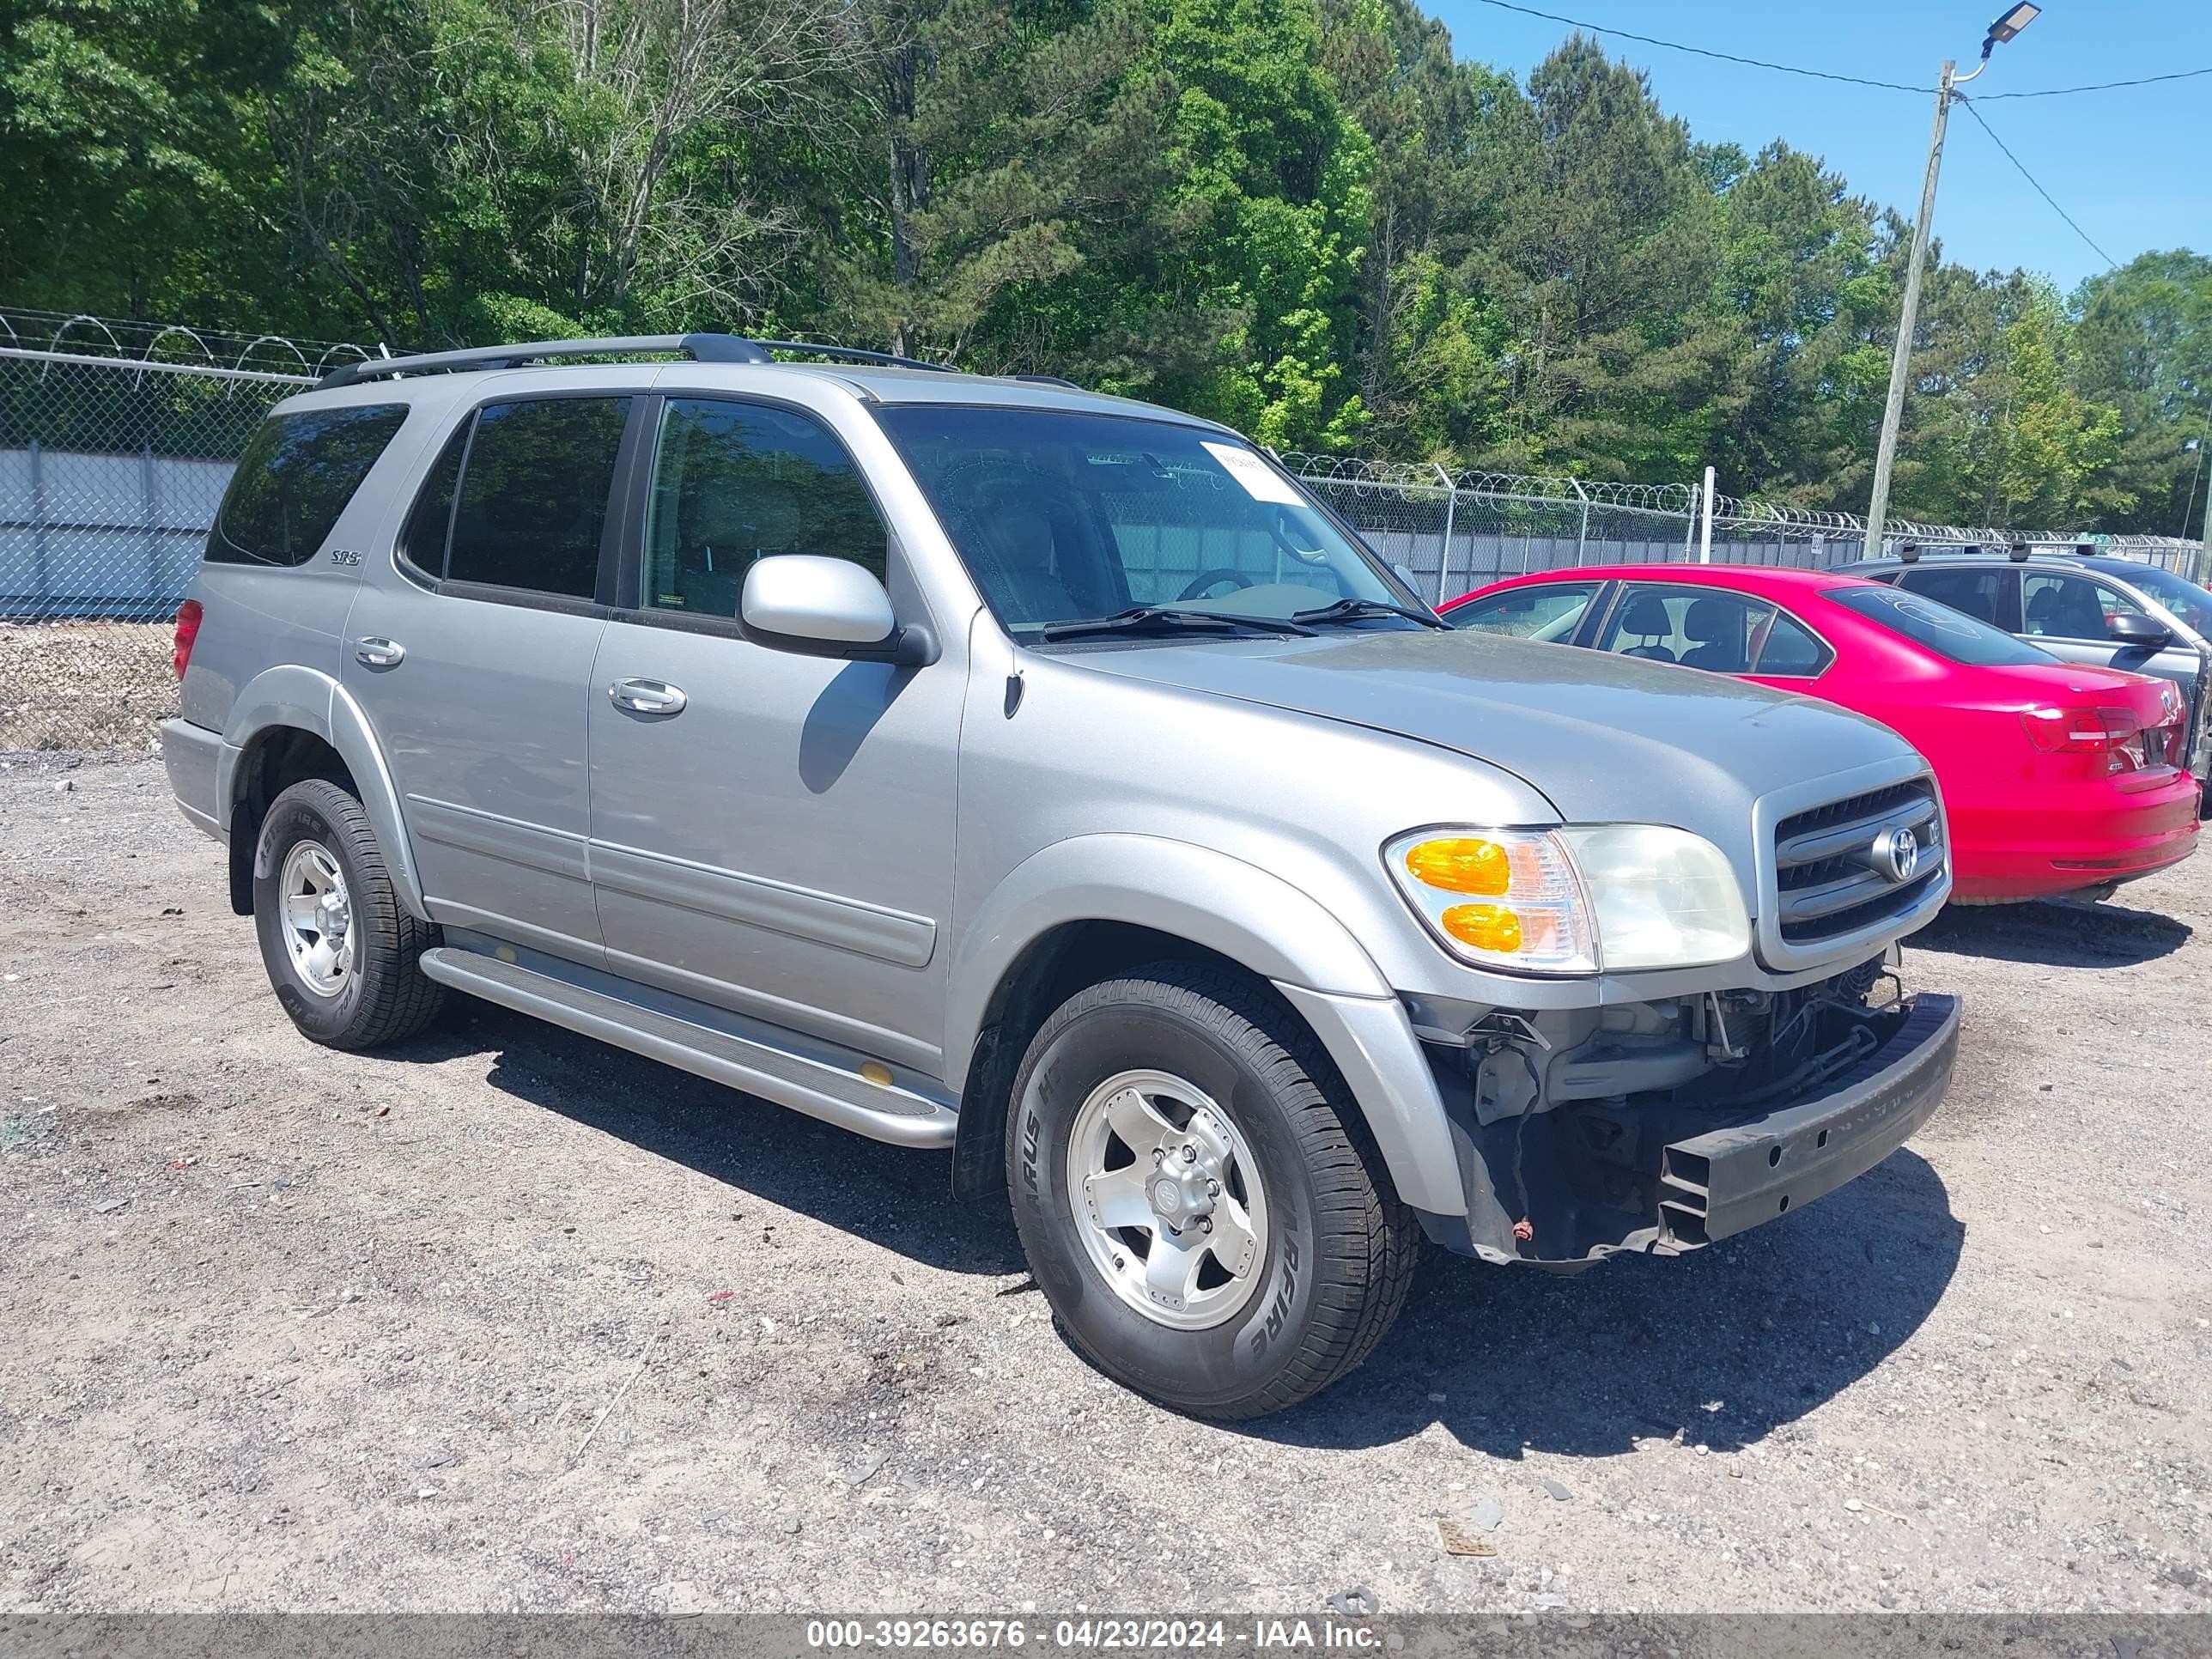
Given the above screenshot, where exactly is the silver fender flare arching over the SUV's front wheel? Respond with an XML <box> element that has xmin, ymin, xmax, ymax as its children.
<box><xmin>945</xmin><ymin>834</ymin><xmax>1464</xmax><ymax>1214</ymax></box>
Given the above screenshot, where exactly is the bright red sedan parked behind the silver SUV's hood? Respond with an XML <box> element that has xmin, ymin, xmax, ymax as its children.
<box><xmin>1443</xmin><ymin>564</ymin><xmax>2197</xmax><ymax>905</ymax></box>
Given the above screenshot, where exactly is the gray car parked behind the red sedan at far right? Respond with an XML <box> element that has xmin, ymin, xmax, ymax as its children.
<box><xmin>1836</xmin><ymin>546</ymin><xmax>2212</xmax><ymax>781</ymax></box>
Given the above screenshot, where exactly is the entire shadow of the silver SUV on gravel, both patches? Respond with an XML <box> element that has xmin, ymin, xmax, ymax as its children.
<box><xmin>414</xmin><ymin>1002</ymin><xmax>1964</xmax><ymax>1458</ymax></box>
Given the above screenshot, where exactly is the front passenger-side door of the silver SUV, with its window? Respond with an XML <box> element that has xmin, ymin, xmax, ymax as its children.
<box><xmin>591</xmin><ymin>394</ymin><xmax>967</xmax><ymax>1075</ymax></box>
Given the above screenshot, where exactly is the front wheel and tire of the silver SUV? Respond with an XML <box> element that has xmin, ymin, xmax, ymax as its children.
<box><xmin>1006</xmin><ymin>963</ymin><xmax>1420</xmax><ymax>1418</ymax></box>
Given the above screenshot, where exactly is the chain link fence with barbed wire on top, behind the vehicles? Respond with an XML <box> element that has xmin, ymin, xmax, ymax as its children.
<box><xmin>0</xmin><ymin>310</ymin><xmax>2212</xmax><ymax>750</ymax></box>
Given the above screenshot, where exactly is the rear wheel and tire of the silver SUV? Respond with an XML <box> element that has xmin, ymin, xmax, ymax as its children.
<box><xmin>254</xmin><ymin>779</ymin><xmax>445</xmax><ymax>1048</ymax></box>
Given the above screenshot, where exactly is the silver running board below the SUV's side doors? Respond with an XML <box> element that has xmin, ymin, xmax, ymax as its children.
<box><xmin>420</xmin><ymin>945</ymin><xmax>960</xmax><ymax>1148</ymax></box>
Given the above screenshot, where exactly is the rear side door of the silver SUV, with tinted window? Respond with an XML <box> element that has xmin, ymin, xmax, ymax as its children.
<box><xmin>343</xmin><ymin>394</ymin><xmax>637</xmax><ymax>963</ymax></box>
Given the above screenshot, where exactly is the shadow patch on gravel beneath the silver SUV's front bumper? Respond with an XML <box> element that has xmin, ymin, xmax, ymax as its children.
<box><xmin>1230</xmin><ymin>1151</ymin><xmax>1964</xmax><ymax>1460</ymax></box>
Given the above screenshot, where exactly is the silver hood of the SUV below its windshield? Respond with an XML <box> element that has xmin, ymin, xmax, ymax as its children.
<box><xmin>1071</xmin><ymin>629</ymin><xmax>1911</xmax><ymax>827</ymax></box>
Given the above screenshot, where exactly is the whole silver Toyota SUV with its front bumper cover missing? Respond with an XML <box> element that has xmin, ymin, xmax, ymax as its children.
<box><xmin>164</xmin><ymin>337</ymin><xmax>1958</xmax><ymax>1418</ymax></box>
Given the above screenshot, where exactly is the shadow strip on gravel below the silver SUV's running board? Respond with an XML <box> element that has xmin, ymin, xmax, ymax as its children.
<box><xmin>431</xmin><ymin>1000</ymin><xmax>1026</xmax><ymax>1276</ymax></box>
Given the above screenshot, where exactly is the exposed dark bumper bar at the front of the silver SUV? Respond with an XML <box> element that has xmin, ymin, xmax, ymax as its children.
<box><xmin>1650</xmin><ymin>994</ymin><xmax>1958</xmax><ymax>1252</ymax></box>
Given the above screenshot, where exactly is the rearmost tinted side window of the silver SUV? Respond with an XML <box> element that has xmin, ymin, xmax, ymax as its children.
<box><xmin>208</xmin><ymin>403</ymin><xmax>407</xmax><ymax>564</ymax></box>
